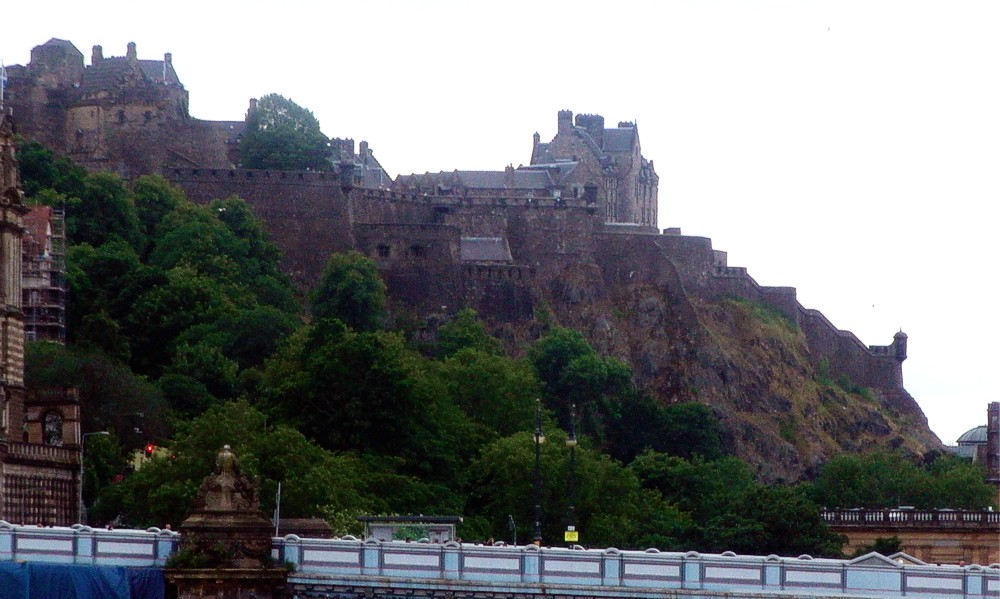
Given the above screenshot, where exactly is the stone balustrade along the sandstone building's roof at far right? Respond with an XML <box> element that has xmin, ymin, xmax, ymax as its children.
<box><xmin>822</xmin><ymin>509</ymin><xmax>1000</xmax><ymax>528</ymax></box>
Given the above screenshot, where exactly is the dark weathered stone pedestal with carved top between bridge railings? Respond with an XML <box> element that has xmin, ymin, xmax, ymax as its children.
<box><xmin>164</xmin><ymin>445</ymin><xmax>288</xmax><ymax>599</ymax></box>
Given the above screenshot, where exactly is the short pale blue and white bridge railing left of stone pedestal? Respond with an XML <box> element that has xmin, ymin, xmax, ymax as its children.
<box><xmin>0</xmin><ymin>520</ymin><xmax>180</xmax><ymax>567</ymax></box>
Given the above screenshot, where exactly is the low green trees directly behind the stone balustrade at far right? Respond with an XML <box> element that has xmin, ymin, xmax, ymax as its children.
<box><xmin>811</xmin><ymin>452</ymin><xmax>996</xmax><ymax>510</ymax></box>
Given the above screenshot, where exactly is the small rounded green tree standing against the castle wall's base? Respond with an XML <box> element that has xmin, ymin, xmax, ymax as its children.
<box><xmin>309</xmin><ymin>251</ymin><xmax>386</xmax><ymax>331</ymax></box>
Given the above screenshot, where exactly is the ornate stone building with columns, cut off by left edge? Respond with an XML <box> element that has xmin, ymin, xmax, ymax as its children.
<box><xmin>0</xmin><ymin>113</ymin><xmax>81</xmax><ymax>525</ymax></box>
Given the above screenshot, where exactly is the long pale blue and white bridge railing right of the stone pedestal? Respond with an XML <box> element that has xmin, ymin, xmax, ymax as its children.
<box><xmin>274</xmin><ymin>535</ymin><xmax>1000</xmax><ymax>599</ymax></box>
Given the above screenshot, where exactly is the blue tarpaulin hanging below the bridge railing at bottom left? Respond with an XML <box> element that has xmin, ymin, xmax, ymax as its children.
<box><xmin>0</xmin><ymin>562</ymin><xmax>164</xmax><ymax>599</ymax></box>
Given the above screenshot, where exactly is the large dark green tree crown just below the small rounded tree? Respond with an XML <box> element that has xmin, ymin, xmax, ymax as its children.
<box><xmin>264</xmin><ymin>319</ymin><xmax>473</xmax><ymax>488</ymax></box>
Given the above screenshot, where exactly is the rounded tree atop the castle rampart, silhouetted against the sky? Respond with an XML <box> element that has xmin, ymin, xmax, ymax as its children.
<box><xmin>240</xmin><ymin>94</ymin><xmax>331</xmax><ymax>170</ymax></box>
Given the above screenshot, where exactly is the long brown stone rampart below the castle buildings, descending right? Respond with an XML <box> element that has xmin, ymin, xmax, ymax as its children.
<box><xmin>165</xmin><ymin>168</ymin><xmax>905</xmax><ymax>389</ymax></box>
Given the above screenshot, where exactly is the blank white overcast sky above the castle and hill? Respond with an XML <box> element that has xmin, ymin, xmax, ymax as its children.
<box><xmin>0</xmin><ymin>0</ymin><xmax>1000</xmax><ymax>442</ymax></box>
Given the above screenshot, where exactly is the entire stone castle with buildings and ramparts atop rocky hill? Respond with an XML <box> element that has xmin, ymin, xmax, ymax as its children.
<box><xmin>1</xmin><ymin>40</ymin><xmax>940</xmax><ymax>478</ymax></box>
